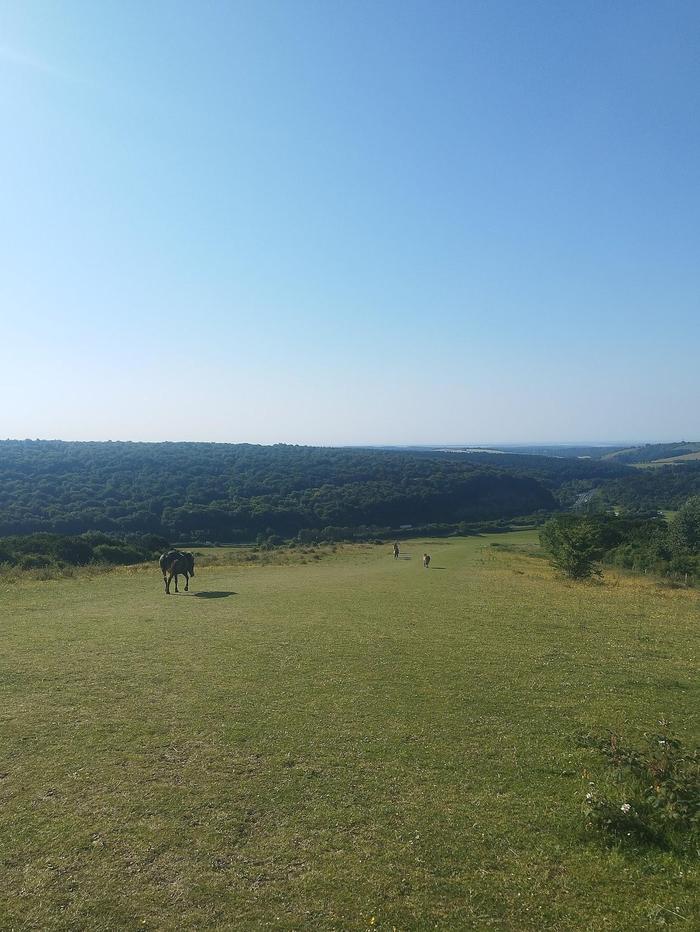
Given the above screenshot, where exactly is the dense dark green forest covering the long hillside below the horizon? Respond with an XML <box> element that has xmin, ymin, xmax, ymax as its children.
<box><xmin>0</xmin><ymin>440</ymin><xmax>700</xmax><ymax>546</ymax></box>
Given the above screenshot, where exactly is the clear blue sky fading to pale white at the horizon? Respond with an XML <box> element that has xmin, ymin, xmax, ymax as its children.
<box><xmin>0</xmin><ymin>0</ymin><xmax>700</xmax><ymax>444</ymax></box>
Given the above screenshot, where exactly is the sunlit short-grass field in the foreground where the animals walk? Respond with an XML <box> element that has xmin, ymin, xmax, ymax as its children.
<box><xmin>0</xmin><ymin>532</ymin><xmax>700</xmax><ymax>932</ymax></box>
